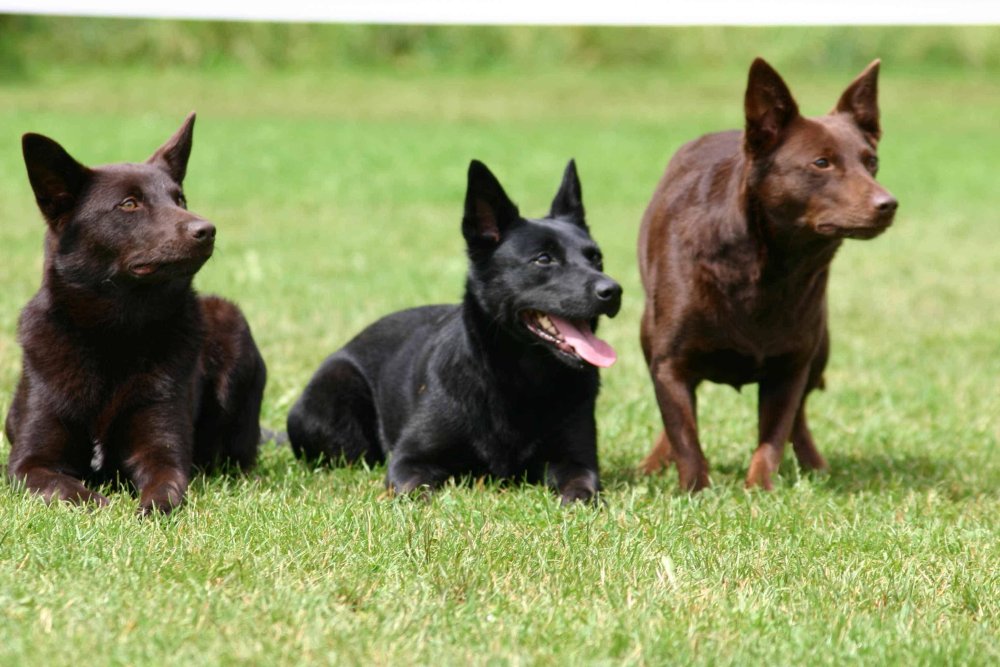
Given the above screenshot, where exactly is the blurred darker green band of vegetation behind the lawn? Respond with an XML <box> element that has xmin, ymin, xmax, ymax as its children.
<box><xmin>0</xmin><ymin>16</ymin><xmax>1000</xmax><ymax>77</ymax></box>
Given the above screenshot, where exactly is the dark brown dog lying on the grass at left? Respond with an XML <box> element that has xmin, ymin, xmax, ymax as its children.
<box><xmin>6</xmin><ymin>114</ymin><xmax>266</xmax><ymax>513</ymax></box>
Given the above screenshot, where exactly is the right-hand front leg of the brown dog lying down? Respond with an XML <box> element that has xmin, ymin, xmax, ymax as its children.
<box><xmin>124</xmin><ymin>405</ymin><xmax>194</xmax><ymax>515</ymax></box>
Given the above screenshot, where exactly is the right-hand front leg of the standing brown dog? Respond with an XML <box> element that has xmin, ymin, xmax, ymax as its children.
<box><xmin>746</xmin><ymin>364</ymin><xmax>809</xmax><ymax>491</ymax></box>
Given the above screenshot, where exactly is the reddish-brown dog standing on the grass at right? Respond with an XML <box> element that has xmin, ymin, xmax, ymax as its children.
<box><xmin>639</xmin><ymin>58</ymin><xmax>897</xmax><ymax>491</ymax></box>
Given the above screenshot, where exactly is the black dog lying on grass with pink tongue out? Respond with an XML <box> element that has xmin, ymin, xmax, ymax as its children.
<box><xmin>288</xmin><ymin>161</ymin><xmax>621</xmax><ymax>503</ymax></box>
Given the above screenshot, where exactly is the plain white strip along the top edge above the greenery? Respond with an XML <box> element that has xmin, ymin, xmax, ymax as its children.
<box><xmin>0</xmin><ymin>0</ymin><xmax>1000</xmax><ymax>26</ymax></box>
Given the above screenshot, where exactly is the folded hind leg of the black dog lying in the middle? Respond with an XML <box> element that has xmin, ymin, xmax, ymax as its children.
<box><xmin>288</xmin><ymin>356</ymin><xmax>385</xmax><ymax>465</ymax></box>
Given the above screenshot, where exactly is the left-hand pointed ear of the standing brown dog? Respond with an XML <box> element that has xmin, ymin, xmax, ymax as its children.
<box><xmin>743</xmin><ymin>58</ymin><xmax>799</xmax><ymax>155</ymax></box>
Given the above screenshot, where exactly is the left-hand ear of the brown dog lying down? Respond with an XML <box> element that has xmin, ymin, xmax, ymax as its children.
<box><xmin>21</xmin><ymin>133</ymin><xmax>93</xmax><ymax>231</ymax></box>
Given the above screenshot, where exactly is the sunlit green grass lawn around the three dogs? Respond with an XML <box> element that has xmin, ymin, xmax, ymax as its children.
<box><xmin>0</xmin><ymin>37</ymin><xmax>1000</xmax><ymax>665</ymax></box>
